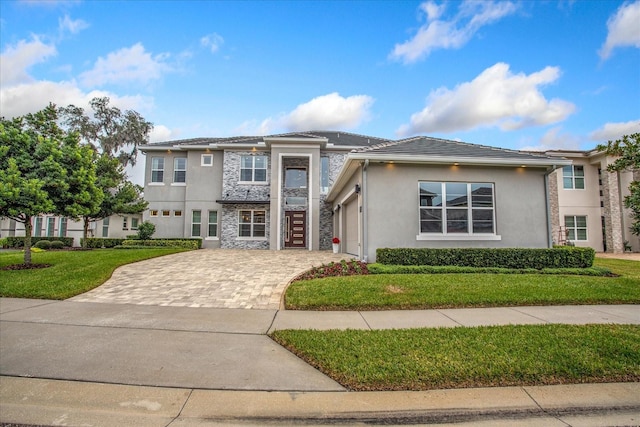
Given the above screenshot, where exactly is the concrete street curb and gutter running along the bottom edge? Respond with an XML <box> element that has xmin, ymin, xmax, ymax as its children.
<box><xmin>0</xmin><ymin>376</ymin><xmax>640</xmax><ymax>426</ymax></box>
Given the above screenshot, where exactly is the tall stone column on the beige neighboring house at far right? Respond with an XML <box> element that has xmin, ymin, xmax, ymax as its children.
<box><xmin>601</xmin><ymin>159</ymin><xmax>624</xmax><ymax>253</ymax></box>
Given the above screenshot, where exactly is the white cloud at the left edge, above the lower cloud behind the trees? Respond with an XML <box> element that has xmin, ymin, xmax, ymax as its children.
<box><xmin>0</xmin><ymin>35</ymin><xmax>57</xmax><ymax>86</ymax></box>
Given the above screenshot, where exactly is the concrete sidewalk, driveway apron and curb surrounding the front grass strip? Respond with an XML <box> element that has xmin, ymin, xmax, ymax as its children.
<box><xmin>0</xmin><ymin>298</ymin><xmax>640</xmax><ymax>426</ymax></box>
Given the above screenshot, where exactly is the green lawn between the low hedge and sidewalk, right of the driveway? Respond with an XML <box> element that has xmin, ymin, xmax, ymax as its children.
<box><xmin>285</xmin><ymin>259</ymin><xmax>640</xmax><ymax>310</ymax></box>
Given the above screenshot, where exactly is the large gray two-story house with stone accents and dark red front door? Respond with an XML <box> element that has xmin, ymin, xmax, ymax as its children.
<box><xmin>141</xmin><ymin>131</ymin><xmax>571</xmax><ymax>262</ymax></box>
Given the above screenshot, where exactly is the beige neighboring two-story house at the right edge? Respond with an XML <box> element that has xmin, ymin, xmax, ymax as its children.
<box><xmin>545</xmin><ymin>150</ymin><xmax>640</xmax><ymax>252</ymax></box>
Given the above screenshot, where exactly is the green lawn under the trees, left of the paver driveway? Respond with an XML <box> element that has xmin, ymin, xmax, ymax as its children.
<box><xmin>0</xmin><ymin>248</ymin><xmax>189</xmax><ymax>299</ymax></box>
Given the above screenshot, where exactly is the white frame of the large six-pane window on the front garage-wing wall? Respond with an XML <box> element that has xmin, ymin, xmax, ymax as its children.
<box><xmin>416</xmin><ymin>181</ymin><xmax>502</xmax><ymax>240</ymax></box>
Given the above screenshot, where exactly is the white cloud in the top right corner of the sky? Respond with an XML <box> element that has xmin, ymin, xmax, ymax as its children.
<box><xmin>598</xmin><ymin>1</ymin><xmax>640</xmax><ymax>60</ymax></box>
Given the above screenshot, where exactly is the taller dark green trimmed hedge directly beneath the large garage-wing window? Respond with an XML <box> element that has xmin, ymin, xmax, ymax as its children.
<box><xmin>376</xmin><ymin>246</ymin><xmax>596</xmax><ymax>270</ymax></box>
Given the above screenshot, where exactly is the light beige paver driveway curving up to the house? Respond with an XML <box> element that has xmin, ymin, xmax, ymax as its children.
<box><xmin>71</xmin><ymin>249</ymin><xmax>352</xmax><ymax>309</ymax></box>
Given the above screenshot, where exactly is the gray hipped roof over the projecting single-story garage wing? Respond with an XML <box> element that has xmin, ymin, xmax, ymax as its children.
<box><xmin>355</xmin><ymin>136</ymin><xmax>549</xmax><ymax>160</ymax></box>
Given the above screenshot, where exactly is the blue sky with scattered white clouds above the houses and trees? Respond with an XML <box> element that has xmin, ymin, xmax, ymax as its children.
<box><xmin>0</xmin><ymin>0</ymin><xmax>640</xmax><ymax>182</ymax></box>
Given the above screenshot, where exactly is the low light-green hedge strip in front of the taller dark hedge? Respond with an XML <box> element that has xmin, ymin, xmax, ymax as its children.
<box><xmin>367</xmin><ymin>263</ymin><xmax>615</xmax><ymax>277</ymax></box>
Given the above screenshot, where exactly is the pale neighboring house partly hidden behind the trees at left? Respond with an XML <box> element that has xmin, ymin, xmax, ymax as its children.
<box><xmin>0</xmin><ymin>214</ymin><xmax>142</xmax><ymax>246</ymax></box>
